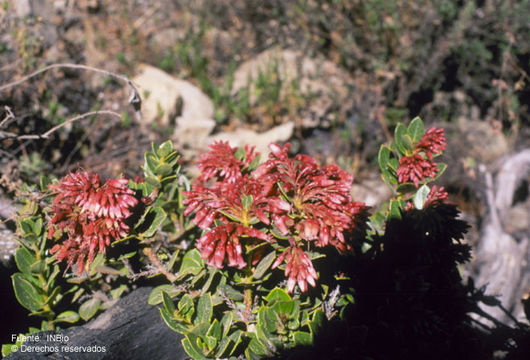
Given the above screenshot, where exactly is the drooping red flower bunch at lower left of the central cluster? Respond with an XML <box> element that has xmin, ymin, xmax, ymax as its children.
<box><xmin>197</xmin><ymin>223</ymin><xmax>270</xmax><ymax>269</ymax></box>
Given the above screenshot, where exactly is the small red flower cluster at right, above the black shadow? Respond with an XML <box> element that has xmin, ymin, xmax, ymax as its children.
<box><xmin>397</xmin><ymin>128</ymin><xmax>446</xmax><ymax>187</ymax></box>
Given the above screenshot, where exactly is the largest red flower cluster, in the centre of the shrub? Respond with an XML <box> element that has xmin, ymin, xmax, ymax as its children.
<box><xmin>184</xmin><ymin>143</ymin><xmax>367</xmax><ymax>291</ymax></box>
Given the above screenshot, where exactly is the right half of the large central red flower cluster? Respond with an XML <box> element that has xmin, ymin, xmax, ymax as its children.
<box><xmin>253</xmin><ymin>144</ymin><xmax>365</xmax><ymax>252</ymax></box>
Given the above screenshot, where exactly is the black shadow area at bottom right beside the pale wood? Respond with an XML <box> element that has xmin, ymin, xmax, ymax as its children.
<box><xmin>266</xmin><ymin>204</ymin><xmax>530</xmax><ymax>359</ymax></box>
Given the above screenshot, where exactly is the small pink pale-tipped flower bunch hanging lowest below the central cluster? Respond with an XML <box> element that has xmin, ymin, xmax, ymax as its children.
<box><xmin>271</xmin><ymin>246</ymin><xmax>318</xmax><ymax>293</ymax></box>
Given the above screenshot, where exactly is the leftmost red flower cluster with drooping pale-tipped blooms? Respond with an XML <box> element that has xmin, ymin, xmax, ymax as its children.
<box><xmin>48</xmin><ymin>171</ymin><xmax>138</xmax><ymax>274</ymax></box>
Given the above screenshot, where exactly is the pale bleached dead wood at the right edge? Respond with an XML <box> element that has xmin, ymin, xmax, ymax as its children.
<box><xmin>472</xmin><ymin>149</ymin><xmax>530</xmax><ymax>325</ymax></box>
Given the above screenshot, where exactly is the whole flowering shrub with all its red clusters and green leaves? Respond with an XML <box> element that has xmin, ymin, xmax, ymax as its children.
<box><xmin>9</xmin><ymin>118</ymin><xmax>490</xmax><ymax>359</ymax></box>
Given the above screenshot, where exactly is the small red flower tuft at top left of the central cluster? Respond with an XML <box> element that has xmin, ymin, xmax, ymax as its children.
<box><xmin>198</xmin><ymin>141</ymin><xmax>257</xmax><ymax>183</ymax></box>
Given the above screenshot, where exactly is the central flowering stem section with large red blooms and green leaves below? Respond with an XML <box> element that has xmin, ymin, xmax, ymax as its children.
<box><xmin>144</xmin><ymin>142</ymin><xmax>368</xmax><ymax>359</ymax></box>
